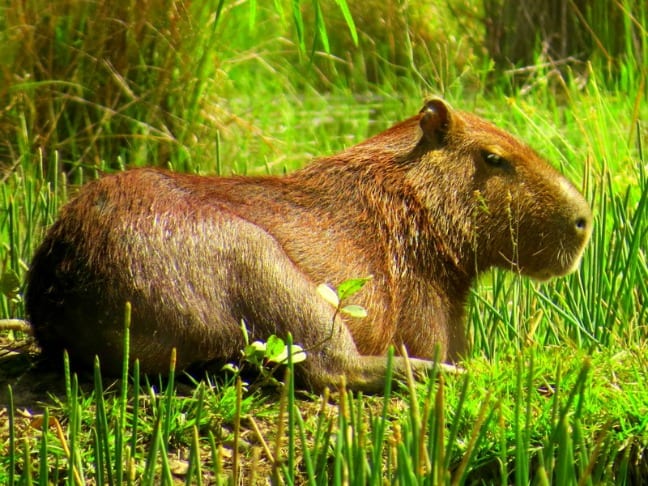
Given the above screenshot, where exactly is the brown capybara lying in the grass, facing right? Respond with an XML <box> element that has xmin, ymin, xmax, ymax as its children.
<box><xmin>26</xmin><ymin>99</ymin><xmax>592</xmax><ymax>392</ymax></box>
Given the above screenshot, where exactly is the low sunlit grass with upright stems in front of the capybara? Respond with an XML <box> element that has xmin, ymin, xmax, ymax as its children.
<box><xmin>3</xmin><ymin>347</ymin><xmax>648</xmax><ymax>484</ymax></box>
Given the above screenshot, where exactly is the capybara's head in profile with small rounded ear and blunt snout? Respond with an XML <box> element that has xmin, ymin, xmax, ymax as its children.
<box><xmin>409</xmin><ymin>99</ymin><xmax>592</xmax><ymax>280</ymax></box>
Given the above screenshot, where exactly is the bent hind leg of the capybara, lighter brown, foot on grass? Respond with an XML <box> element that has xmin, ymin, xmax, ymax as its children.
<box><xmin>218</xmin><ymin>223</ymin><xmax>410</xmax><ymax>392</ymax></box>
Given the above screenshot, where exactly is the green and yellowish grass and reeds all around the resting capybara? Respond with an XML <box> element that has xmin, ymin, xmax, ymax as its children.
<box><xmin>0</xmin><ymin>0</ymin><xmax>648</xmax><ymax>484</ymax></box>
